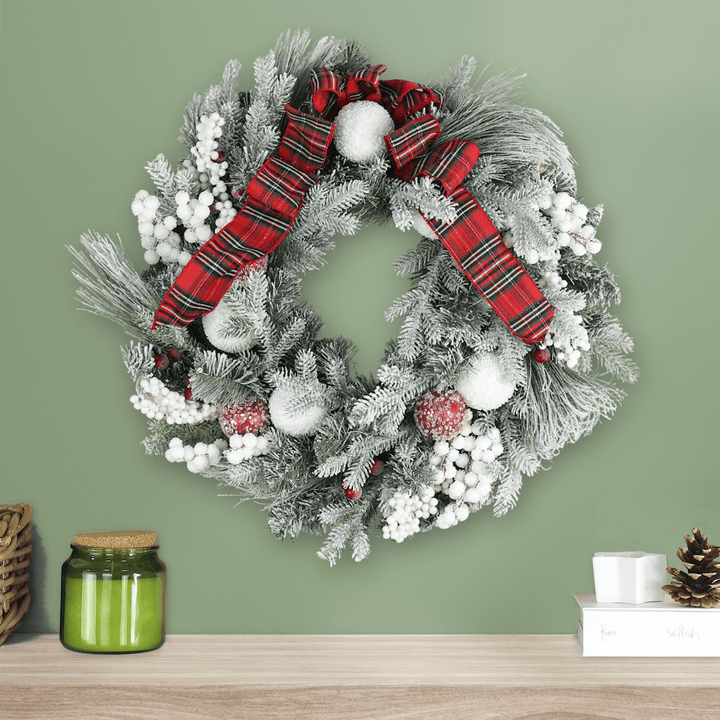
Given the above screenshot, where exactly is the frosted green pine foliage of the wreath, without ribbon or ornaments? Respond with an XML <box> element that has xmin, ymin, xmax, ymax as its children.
<box><xmin>72</xmin><ymin>32</ymin><xmax>637</xmax><ymax>564</ymax></box>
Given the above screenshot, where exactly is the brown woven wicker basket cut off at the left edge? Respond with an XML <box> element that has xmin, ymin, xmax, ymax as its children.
<box><xmin>0</xmin><ymin>505</ymin><xmax>32</xmax><ymax>645</ymax></box>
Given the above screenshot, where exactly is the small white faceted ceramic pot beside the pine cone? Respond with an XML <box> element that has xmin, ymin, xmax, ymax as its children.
<box><xmin>593</xmin><ymin>551</ymin><xmax>667</xmax><ymax>605</ymax></box>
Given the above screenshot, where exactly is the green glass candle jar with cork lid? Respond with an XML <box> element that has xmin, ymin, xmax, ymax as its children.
<box><xmin>60</xmin><ymin>531</ymin><xmax>167</xmax><ymax>653</ymax></box>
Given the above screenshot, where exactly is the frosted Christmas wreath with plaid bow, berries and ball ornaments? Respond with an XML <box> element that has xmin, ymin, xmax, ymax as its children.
<box><xmin>71</xmin><ymin>32</ymin><xmax>637</xmax><ymax>563</ymax></box>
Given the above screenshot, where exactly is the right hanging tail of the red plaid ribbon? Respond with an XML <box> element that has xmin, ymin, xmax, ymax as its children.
<box><xmin>424</xmin><ymin>185</ymin><xmax>555</xmax><ymax>345</ymax></box>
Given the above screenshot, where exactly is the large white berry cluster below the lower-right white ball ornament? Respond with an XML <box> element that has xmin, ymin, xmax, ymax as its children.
<box><xmin>430</xmin><ymin>423</ymin><xmax>504</xmax><ymax>529</ymax></box>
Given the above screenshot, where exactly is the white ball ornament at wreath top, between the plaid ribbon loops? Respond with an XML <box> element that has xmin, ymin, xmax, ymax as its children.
<box><xmin>334</xmin><ymin>100</ymin><xmax>395</xmax><ymax>162</ymax></box>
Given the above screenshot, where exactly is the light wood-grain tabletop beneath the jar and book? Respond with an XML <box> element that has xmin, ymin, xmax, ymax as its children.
<box><xmin>0</xmin><ymin>634</ymin><xmax>720</xmax><ymax>720</ymax></box>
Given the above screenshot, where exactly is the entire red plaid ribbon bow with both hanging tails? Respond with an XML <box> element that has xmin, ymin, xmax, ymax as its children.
<box><xmin>153</xmin><ymin>65</ymin><xmax>555</xmax><ymax>344</ymax></box>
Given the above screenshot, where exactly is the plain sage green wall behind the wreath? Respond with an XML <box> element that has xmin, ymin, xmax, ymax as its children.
<box><xmin>0</xmin><ymin>0</ymin><xmax>720</xmax><ymax>633</ymax></box>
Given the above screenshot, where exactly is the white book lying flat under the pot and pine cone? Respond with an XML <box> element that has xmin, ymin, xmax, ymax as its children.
<box><xmin>575</xmin><ymin>595</ymin><xmax>720</xmax><ymax>657</ymax></box>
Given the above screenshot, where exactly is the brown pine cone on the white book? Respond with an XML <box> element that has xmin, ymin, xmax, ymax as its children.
<box><xmin>663</xmin><ymin>528</ymin><xmax>720</xmax><ymax>607</ymax></box>
